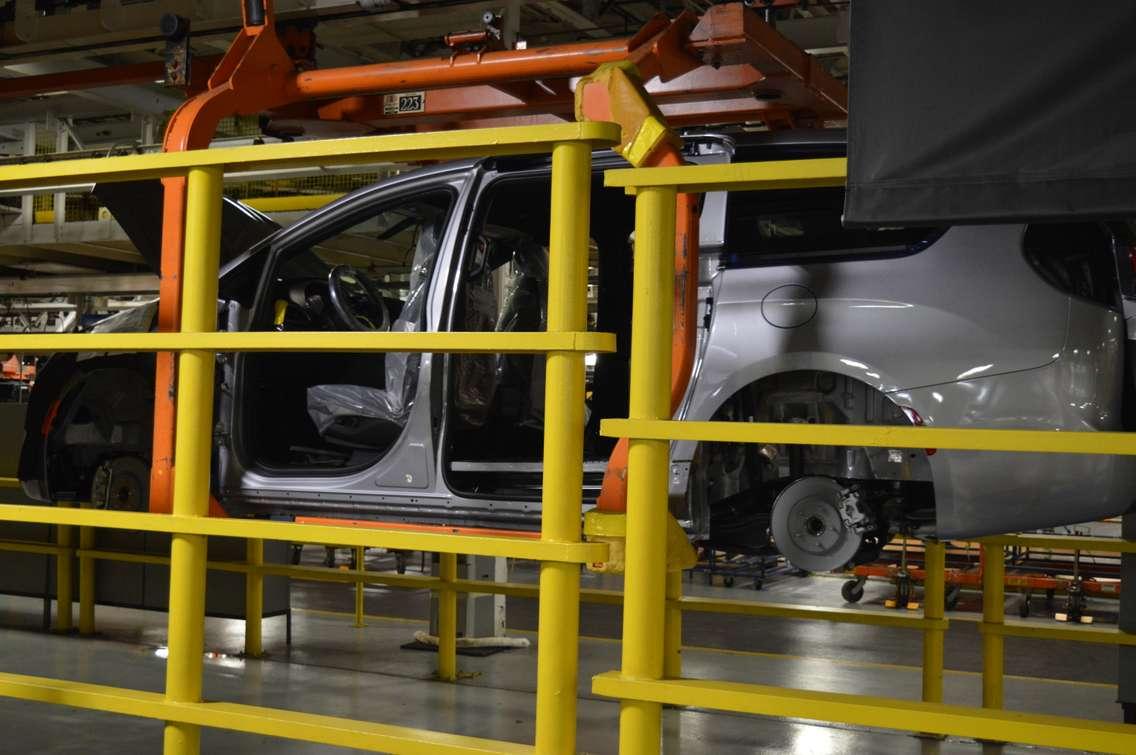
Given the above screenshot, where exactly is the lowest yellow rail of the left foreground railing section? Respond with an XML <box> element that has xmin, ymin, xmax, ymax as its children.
<box><xmin>0</xmin><ymin>673</ymin><xmax>534</xmax><ymax>755</ymax></box>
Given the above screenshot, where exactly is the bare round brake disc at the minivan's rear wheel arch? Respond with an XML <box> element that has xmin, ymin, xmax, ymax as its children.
<box><xmin>770</xmin><ymin>477</ymin><xmax>863</xmax><ymax>571</ymax></box>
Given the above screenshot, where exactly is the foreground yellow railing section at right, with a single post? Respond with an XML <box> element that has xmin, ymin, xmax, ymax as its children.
<box><xmin>592</xmin><ymin>159</ymin><xmax>1136</xmax><ymax>755</ymax></box>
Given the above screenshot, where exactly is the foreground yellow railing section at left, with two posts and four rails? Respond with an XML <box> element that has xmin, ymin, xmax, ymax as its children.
<box><xmin>0</xmin><ymin>123</ymin><xmax>619</xmax><ymax>753</ymax></box>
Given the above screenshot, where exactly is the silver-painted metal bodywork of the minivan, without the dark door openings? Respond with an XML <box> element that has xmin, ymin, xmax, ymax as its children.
<box><xmin>20</xmin><ymin>133</ymin><xmax>1136</xmax><ymax>557</ymax></box>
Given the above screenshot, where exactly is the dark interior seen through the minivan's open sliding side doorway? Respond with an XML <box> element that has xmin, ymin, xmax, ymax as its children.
<box><xmin>444</xmin><ymin>176</ymin><xmax>634</xmax><ymax>497</ymax></box>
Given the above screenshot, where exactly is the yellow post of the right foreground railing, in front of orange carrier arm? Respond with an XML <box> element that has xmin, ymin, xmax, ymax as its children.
<box><xmin>619</xmin><ymin>182</ymin><xmax>676</xmax><ymax>755</ymax></box>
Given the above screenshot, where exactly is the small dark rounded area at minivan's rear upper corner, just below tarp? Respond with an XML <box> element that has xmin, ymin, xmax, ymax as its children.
<box><xmin>1022</xmin><ymin>223</ymin><xmax>1120</xmax><ymax>309</ymax></box>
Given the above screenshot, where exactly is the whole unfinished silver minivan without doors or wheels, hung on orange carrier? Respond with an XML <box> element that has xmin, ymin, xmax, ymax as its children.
<box><xmin>20</xmin><ymin>132</ymin><xmax>1136</xmax><ymax>570</ymax></box>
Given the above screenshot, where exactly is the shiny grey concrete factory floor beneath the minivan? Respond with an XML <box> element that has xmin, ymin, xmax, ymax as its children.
<box><xmin>0</xmin><ymin>548</ymin><xmax>1120</xmax><ymax>755</ymax></box>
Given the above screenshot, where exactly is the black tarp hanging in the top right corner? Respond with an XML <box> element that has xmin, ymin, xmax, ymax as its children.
<box><xmin>845</xmin><ymin>0</ymin><xmax>1136</xmax><ymax>225</ymax></box>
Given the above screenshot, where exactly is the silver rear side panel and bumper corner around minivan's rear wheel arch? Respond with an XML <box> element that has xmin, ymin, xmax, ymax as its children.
<box><xmin>671</xmin><ymin>213</ymin><xmax>1136</xmax><ymax>537</ymax></box>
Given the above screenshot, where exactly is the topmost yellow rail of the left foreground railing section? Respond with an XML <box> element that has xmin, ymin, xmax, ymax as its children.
<box><xmin>0</xmin><ymin>123</ymin><xmax>619</xmax><ymax>190</ymax></box>
